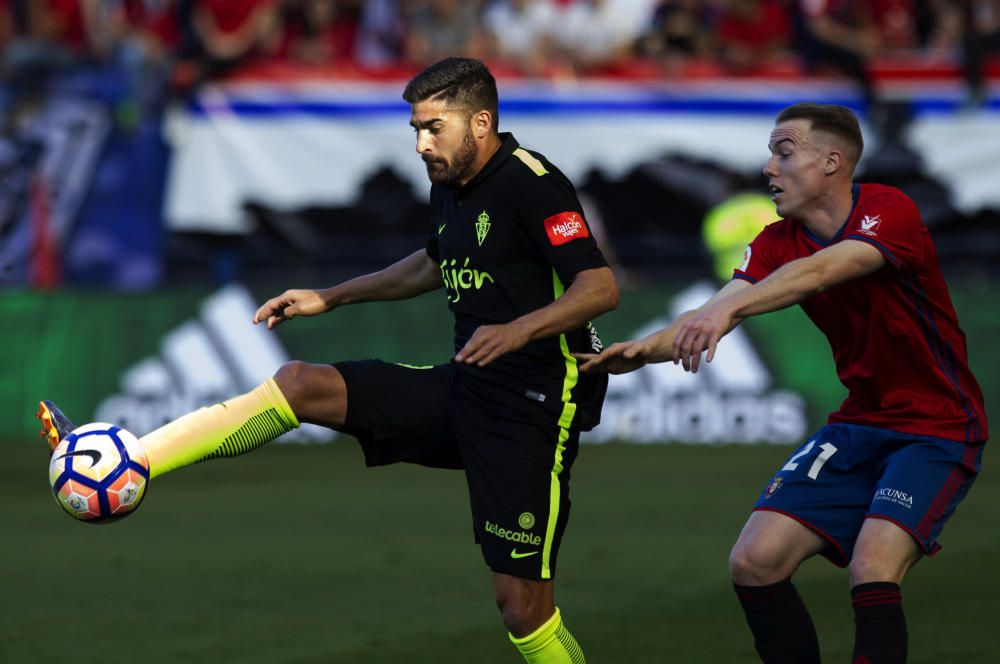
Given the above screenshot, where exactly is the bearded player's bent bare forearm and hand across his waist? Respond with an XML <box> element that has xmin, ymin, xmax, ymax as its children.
<box><xmin>455</xmin><ymin>267</ymin><xmax>618</xmax><ymax>367</ymax></box>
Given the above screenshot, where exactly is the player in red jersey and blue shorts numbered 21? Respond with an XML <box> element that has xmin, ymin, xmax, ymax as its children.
<box><xmin>581</xmin><ymin>104</ymin><xmax>988</xmax><ymax>664</ymax></box>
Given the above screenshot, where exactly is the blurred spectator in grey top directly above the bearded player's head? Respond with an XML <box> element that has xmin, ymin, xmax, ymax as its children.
<box><xmin>405</xmin><ymin>0</ymin><xmax>486</xmax><ymax>64</ymax></box>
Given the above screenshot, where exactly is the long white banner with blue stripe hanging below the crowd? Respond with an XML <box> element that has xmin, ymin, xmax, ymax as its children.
<box><xmin>165</xmin><ymin>81</ymin><xmax>1000</xmax><ymax>234</ymax></box>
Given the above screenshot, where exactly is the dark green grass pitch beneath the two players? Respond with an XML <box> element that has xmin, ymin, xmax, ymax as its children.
<box><xmin>0</xmin><ymin>442</ymin><xmax>1000</xmax><ymax>664</ymax></box>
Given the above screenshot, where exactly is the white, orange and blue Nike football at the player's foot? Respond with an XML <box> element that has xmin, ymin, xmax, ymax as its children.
<box><xmin>49</xmin><ymin>422</ymin><xmax>149</xmax><ymax>523</ymax></box>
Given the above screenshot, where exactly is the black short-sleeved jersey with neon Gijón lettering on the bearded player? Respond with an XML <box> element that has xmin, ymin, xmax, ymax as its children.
<box><xmin>427</xmin><ymin>133</ymin><xmax>607</xmax><ymax>429</ymax></box>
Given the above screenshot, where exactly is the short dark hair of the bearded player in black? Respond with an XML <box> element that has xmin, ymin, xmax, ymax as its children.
<box><xmin>403</xmin><ymin>58</ymin><xmax>499</xmax><ymax>131</ymax></box>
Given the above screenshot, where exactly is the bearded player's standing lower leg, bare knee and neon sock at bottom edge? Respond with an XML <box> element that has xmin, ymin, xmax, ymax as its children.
<box><xmin>493</xmin><ymin>573</ymin><xmax>586</xmax><ymax>664</ymax></box>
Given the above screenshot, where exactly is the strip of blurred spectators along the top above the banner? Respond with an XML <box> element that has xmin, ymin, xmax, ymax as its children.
<box><xmin>0</xmin><ymin>0</ymin><xmax>1000</xmax><ymax>97</ymax></box>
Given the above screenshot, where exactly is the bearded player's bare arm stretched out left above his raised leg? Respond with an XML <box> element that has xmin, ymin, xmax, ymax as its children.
<box><xmin>253</xmin><ymin>249</ymin><xmax>443</xmax><ymax>330</ymax></box>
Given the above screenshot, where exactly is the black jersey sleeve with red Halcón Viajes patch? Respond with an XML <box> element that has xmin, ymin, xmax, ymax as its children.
<box><xmin>515</xmin><ymin>154</ymin><xmax>608</xmax><ymax>284</ymax></box>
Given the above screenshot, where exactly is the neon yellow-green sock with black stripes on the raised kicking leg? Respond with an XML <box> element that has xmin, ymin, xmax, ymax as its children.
<box><xmin>139</xmin><ymin>378</ymin><xmax>299</xmax><ymax>477</ymax></box>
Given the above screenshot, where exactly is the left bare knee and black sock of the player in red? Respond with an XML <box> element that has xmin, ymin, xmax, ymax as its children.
<box><xmin>729</xmin><ymin>511</ymin><xmax>827</xmax><ymax>664</ymax></box>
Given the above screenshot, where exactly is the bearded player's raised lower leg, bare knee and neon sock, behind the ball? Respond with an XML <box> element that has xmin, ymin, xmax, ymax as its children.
<box><xmin>131</xmin><ymin>362</ymin><xmax>347</xmax><ymax>477</ymax></box>
